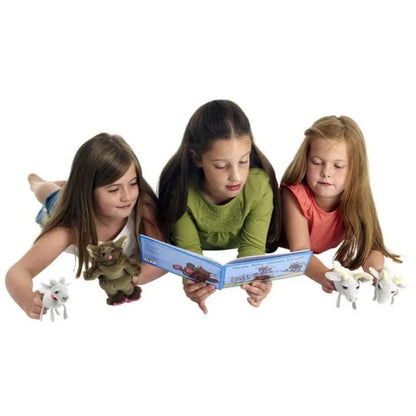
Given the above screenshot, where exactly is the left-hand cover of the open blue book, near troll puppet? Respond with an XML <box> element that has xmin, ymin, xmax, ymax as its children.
<box><xmin>140</xmin><ymin>234</ymin><xmax>222</xmax><ymax>289</ymax></box>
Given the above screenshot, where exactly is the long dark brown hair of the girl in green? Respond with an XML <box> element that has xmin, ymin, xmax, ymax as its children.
<box><xmin>158</xmin><ymin>100</ymin><xmax>282</xmax><ymax>252</ymax></box>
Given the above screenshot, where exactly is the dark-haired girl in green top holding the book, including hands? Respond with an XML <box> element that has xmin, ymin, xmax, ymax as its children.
<box><xmin>158</xmin><ymin>100</ymin><xmax>281</xmax><ymax>313</ymax></box>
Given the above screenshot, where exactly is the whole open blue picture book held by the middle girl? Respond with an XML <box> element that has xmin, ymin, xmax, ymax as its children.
<box><xmin>140</xmin><ymin>234</ymin><xmax>312</xmax><ymax>289</ymax></box>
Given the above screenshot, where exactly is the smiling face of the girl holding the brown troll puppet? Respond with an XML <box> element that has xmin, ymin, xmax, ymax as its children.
<box><xmin>94</xmin><ymin>164</ymin><xmax>139</xmax><ymax>219</ymax></box>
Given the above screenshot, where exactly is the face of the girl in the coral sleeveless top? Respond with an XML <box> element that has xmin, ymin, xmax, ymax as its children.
<box><xmin>306</xmin><ymin>139</ymin><xmax>348</xmax><ymax>211</ymax></box>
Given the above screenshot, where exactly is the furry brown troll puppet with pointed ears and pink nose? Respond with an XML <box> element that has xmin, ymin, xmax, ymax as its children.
<box><xmin>84</xmin><ymin>236</ymin><xmax>142</xmax><ymax>305</ymax></box>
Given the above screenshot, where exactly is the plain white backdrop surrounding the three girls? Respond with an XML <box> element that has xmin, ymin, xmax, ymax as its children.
<box><xmin>0</xmin><ymin>0</ymin><xmax>416</xmax><ymax>416</ymax></box>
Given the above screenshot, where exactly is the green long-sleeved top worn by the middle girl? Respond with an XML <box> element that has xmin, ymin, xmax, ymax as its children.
<box><xmin>172</xmin><ymin>168</ymin><xmax>273</xmax><ymax>257</ymax></box>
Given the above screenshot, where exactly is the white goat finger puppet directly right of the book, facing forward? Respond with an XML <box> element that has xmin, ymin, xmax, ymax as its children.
<box><xmin>325</xmin><ymin>261</ymin><xmax>373</xmax><ymax>309</ymax></box>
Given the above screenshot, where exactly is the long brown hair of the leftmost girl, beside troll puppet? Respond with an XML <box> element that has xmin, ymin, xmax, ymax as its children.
<box><xmin>37</xmin><ymin>133</ymin><xmax>156</xmax><ymax>277</ymax></box>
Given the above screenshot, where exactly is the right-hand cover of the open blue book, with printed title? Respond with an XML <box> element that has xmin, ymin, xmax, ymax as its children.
<box><xmin>223</xmin><ymin>251</ymin><xmax>312</xmax><ymax>287</ymax></box>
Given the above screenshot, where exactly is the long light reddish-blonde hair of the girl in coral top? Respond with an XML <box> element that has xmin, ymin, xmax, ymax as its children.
<box><xmin>281</xmin><ymin>116</ymin><xmax>401</xmax><ymax>269</ymax></box>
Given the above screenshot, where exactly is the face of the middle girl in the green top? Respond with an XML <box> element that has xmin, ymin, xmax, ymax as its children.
<box><xmin>194</xmin><ymin>136</ymin><xmax>251</xmax><ymax>204</ymax></box>
